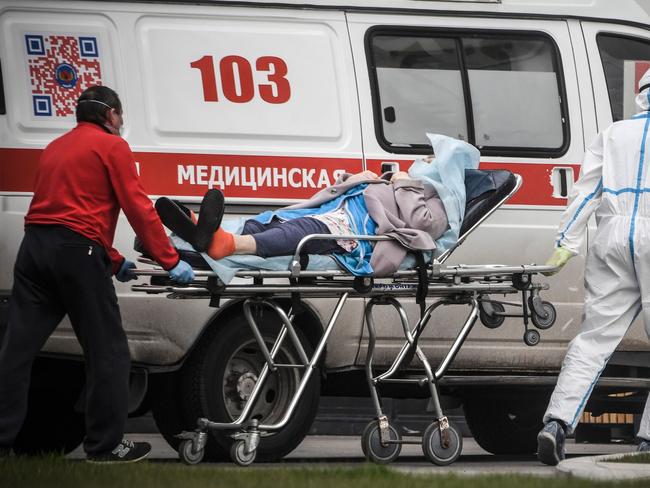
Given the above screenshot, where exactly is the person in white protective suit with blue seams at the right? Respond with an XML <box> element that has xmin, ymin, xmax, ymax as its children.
<box><xmin>537</xmin><ymin>70</ymin><xmax>650</xmax><ymax>465</ymax></box>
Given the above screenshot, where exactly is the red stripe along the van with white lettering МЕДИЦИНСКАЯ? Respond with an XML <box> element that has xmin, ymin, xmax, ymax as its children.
<box><xmin>0</xmin><ymin>149</ymin><xmax>580</xmax><ymax>206</ymax></box>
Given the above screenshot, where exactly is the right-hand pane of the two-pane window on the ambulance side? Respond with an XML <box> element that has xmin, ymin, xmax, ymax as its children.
<box><xmin>463</xmin><ymin>36</ymin><xmax>564</xmax><ymax>149</ymax></box>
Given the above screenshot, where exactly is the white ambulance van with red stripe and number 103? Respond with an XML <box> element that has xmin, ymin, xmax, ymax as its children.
<box><xmin>0</xmin><ymin>0</ymin><xmax>650</xmax><ymax>460</ymax></box>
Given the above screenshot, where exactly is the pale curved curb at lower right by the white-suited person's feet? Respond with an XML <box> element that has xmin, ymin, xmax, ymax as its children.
<box><xmin>556</xmin><ymin>451</ymin><xmax>650</xmax><ymax>480</ymax></box>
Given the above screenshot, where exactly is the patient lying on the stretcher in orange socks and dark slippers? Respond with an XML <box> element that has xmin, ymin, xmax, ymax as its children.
<box><xmin>156</xmin><ymin>136</ymin><xmax>478</xmax><ymax>276</ymax></box>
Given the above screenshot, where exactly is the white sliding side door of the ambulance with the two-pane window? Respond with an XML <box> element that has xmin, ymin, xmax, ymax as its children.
<box><xmin>349</xmin><ymin>14</ymin><xmax>583</xmax><ymax>369</ymax></box>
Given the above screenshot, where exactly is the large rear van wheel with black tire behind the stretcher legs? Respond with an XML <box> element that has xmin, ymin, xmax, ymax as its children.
<box><xmin>181</xmin><ymin>310</ymin><xmax>320</xmax><ymax>461</ymax></box>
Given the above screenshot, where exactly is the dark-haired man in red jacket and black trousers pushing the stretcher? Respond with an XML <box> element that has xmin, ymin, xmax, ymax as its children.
<box><xmin>0</xmin><ymin>86</ymin><xmax>194</xmax><ymax>462</ymax></box>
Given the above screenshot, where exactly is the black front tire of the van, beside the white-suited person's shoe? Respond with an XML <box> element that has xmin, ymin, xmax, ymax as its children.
<box><xmin>463</xmin><ymin>391</ymin><xmax>549</xmax><ymax>455</ymax></box>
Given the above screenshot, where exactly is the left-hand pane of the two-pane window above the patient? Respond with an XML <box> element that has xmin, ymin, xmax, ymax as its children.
<box><xmin>372</xmin><ymin>36</ymin><xmax>467</xmax><ymax>147</ymax></box>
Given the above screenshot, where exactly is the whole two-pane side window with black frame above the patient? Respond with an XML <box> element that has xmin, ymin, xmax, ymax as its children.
<box><xmin>368</xmin><ymin>28</ymin><xmax>568</xmax><ymax>156</ymax></box>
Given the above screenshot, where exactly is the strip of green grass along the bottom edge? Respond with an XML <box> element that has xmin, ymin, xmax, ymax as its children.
<box><xmin>0</xmin><ymin>456</ymin><xmax>648</xmax><ymax>488</ymax></box>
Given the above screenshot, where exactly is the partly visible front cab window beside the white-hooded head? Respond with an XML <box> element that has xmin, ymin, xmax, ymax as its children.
<box><xmin>597</xmin><ymin>34</ymin><xmax>650</xmax><ymax>122</ymax></box>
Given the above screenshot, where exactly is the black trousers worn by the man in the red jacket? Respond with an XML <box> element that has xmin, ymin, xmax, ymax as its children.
<box><xmin>0</xmin><ymin>225</ymin><xmax>131</xmax><ymax>454</ymax></box>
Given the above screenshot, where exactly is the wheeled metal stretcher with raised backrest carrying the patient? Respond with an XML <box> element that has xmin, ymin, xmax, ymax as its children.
<box><xmin>132</xmin><ymin>170</ymin><xmax>556</xmax><ymax>466</ymax></box>
